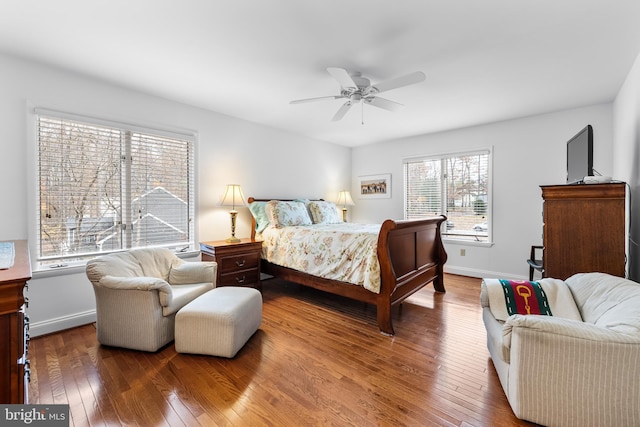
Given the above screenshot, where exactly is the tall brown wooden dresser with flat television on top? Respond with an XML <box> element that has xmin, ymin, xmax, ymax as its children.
<box><xmin>541</xmin><ymin>183</ymin><xmax>626</xmax><ymax>279</ymax></box>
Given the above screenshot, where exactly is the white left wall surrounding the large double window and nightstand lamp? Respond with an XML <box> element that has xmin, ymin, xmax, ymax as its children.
<box><xmin>0</xmin><ymin>55</ymin><xmax>351</xmax><ymax>336</ymax></box>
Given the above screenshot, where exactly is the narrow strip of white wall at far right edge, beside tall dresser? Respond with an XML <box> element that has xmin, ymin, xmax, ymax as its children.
<box><xmin>613</xmin><ymin>49</ymin><xmax>640</xmax><ymax>281</ymax></box>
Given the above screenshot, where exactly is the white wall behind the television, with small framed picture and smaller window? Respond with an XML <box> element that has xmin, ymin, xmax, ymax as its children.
<box><xmin>351</xmin><ymin>104</ymin><xmax>616</xmax><ymax>279</ymax></box>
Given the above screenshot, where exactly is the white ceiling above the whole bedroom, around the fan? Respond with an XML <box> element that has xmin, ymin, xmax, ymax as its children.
<box><xmin>0</xmin><ymin>0</ymin><xmax>640</xmax><ymax>146</ymax></box>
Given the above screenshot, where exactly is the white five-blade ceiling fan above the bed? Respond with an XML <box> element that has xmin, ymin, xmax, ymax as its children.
<box><xmin>290</xmin><ymin>67</ymin><xmax>425</xmax><ymax>121</ymax></box>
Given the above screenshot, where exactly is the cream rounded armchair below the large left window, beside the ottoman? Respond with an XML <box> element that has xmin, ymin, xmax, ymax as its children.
<box><xmin>86</xmin><ymin>248</ymin><xmax>217</xmax><ymax>351</ymax></box>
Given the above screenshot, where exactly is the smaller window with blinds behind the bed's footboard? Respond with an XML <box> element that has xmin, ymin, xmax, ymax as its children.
<box><xmin>404</xmin><ymin>150</ymin><xmax>491</xmax><ymax>242</ymax></box>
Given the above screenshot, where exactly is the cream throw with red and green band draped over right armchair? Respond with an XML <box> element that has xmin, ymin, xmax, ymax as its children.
<box><xmin>482</xmin><ymin>278</ymin><xmax>582</xmax><ymax>321</ymax></box>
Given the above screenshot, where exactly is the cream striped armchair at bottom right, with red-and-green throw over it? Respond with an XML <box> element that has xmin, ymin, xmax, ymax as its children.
<box><xmin>480</xmin><ymin>273</ymin><xmax>640</xmax><ymax>427</ymax></box>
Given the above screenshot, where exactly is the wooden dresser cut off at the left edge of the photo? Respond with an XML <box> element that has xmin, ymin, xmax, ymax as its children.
<box><xmin>0</xmin><ymin>240</ymin><xmax>31</xmax><ymax>403</ymax></box>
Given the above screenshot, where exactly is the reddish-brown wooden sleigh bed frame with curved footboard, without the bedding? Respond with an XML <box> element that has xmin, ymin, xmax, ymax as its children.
<box><xmin>249</xmin><ymin>197</ymin><xmax>447</xmax><ymax>335</ymax></box>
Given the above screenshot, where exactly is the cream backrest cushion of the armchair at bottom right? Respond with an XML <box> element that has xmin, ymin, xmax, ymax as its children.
<box><xmin>566</xmin><ymin>273</ymin><xmax>640</xmax><ymax>336</ymax></box>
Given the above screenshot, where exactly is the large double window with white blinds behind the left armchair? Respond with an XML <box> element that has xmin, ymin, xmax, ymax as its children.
<box><xmin>37</xmin><ymin>114</ymin><xmax>195</xmax><ymax>265</ymax></box>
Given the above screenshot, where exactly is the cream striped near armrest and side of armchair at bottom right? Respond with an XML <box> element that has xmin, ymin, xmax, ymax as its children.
<box><xmin>503</xmin><ymin>316</ymin><xmax>640</xmax><ymax>426</ymax></box>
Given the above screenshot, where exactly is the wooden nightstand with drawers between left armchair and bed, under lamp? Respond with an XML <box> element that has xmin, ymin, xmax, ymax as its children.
<box><xmin>200</xmin><ymin>239</ymin><xmax>262</xmax><ymax>289</ymax></box>
